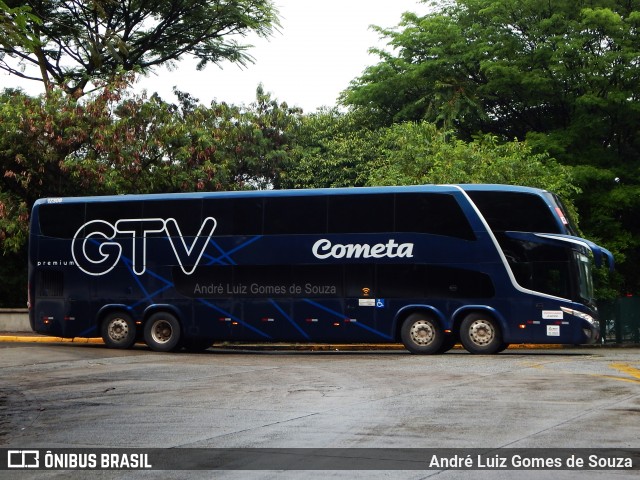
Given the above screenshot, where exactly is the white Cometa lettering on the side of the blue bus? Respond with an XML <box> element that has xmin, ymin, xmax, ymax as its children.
<box><xmin>312</xmin><ymin>238</ymin><xmax>413</xmax><ymax>260</ymax></box>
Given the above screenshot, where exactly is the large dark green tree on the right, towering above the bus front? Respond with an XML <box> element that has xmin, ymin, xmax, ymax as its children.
<box><xmin>341</xmin><ymin>0</ymin><xmax>640</xmax><ymax>293</ymax></box>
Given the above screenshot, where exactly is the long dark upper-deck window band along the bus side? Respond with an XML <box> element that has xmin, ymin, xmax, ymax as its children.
<box><xmin>39</xmin><ymin>188</ymin><xmax>475</xmax><ymax>240</ymax></box>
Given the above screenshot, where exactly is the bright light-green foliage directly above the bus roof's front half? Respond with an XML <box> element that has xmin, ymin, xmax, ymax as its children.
<box><xmin>284</xmin><ymin>110</ymin><xmax>579</xmax><ymax>201</ymax></box>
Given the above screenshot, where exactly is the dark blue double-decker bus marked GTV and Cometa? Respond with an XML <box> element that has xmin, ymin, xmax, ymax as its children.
<box><xmin>29</xmin><ymin>185</ymin><xmax>613</xmax><ymax>354</ymax></box>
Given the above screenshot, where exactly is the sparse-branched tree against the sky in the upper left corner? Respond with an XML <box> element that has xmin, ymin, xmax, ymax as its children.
<box><xmin>0</xmin><ymin>0</ymin><xmax>278</xmax><ymax>97</ymax></box>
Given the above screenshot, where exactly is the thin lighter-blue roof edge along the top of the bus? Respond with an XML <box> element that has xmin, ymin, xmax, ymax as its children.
<box><xmin>35</xmin><ymin>184</ymin><xmax>546</xmax><ymax>205</ymax></box>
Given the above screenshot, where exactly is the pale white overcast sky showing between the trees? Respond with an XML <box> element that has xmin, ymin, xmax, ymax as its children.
<box><xmin>0</xmin><ymin>0</ymin><xmax>429</xmax><ymax>113</ymax></box>
